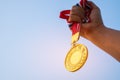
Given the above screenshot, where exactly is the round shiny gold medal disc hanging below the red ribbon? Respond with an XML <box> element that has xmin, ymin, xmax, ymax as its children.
<box><xmin>65</xmin><ymin>44</ymin><xmax>88</xmax><ymax>72</ymax></box>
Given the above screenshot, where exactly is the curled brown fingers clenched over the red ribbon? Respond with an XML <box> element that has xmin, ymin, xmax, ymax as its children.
<box><xmin>69</xmin><ymin>6</ymin><xmax>85</xmax><ymax>23</ymax></box>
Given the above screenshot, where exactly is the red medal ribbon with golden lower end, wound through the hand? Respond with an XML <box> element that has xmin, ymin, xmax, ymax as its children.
<box><xmin>60</xmin><ymin>0</ymin><xmax>91</xmax><ymax>44</ymax></box>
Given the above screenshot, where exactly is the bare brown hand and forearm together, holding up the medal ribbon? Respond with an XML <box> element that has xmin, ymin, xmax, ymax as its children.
<box><xmin>69</xmin><ymin>1</ymin><xmax>120</xmax><ymax>62</ymax></box>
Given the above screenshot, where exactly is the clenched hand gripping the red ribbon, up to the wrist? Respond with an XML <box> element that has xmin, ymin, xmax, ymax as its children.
<box><xmin>69</xmin><ymin>1</ymin><xmax>104</xmax><ymax>39</ymax></box>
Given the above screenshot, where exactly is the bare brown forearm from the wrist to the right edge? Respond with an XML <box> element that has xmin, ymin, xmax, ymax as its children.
<box><xmin>87</xmin><ymin>25</ymin><xmax>120</xmax><ymax>62</ymax></box>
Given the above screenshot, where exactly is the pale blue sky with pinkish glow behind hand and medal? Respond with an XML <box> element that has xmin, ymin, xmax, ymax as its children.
<box><xmin>0</xmin><ymin>0</ymin><xmax>120</xmax><ymax>80</ymax></box>
